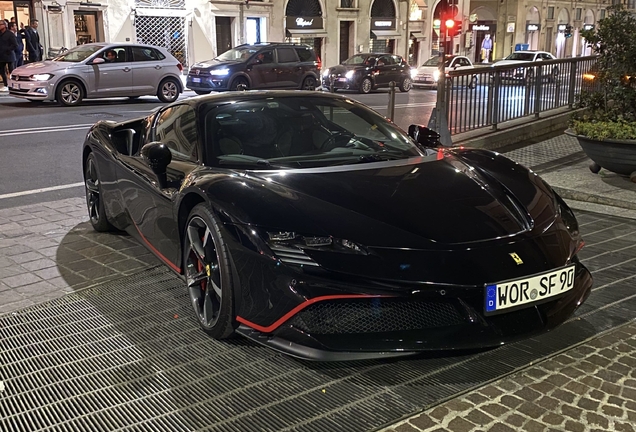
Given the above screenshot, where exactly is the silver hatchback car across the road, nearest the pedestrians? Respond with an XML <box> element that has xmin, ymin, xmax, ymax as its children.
<box><xmin>9</xmin><ymin>43</ymin><xmax>183</xmax><ymax>106</ymax></box>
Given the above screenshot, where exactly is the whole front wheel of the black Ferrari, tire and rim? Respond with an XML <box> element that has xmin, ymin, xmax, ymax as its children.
<box><xmin>183</xmin><ymin>203</ymin><xmax>236</xmax><ymax>339</ymax></box>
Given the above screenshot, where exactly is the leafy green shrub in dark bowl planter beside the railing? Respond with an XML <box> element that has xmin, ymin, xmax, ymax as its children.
<box><xmin>565</xmin><ymin>4</ymin><xmax>636</xmax><ymax>182</ymax></box>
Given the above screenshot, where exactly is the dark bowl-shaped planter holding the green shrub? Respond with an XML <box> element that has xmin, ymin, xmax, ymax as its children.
<box><xmin>565</xmin><ymin>129</ymin><xmax>636</xmax><ymax>176</ymax></box>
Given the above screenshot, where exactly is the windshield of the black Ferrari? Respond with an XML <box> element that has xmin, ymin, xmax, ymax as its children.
<box><xmin>205</xmin><ymin>96</ymin><xmax>424</xmax><ymax>169</ymax></box>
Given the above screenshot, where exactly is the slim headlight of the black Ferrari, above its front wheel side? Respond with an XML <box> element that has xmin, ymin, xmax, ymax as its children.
<box><xmin>267</xmin><ymin>231</ymin><xmax>369</xmax><ymax>255</ymax></box>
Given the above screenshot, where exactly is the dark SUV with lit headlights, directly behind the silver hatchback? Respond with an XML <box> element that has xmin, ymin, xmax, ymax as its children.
<box><xmin>186</xmin><ymin>43</ymin><xmax>321</xmax><ymax>95</ymax></box>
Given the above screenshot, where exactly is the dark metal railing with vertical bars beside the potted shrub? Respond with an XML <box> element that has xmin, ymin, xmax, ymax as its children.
<box><xmin>445</xmin><ymin>56</ymin><xmax>596</xmax><ymax>134</ymax></box>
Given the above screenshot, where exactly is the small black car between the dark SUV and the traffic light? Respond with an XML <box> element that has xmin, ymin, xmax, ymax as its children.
<box><xmin>322</xmin><ymin>53</ymin><xmax>413</xmax><ymax>93</ymax></box>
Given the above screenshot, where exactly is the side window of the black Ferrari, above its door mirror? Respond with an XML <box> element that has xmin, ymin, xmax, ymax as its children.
<box><xmin>154</xmin><ymin>104</ymin><xmax>198</xmax><ymax>162</ymax></box>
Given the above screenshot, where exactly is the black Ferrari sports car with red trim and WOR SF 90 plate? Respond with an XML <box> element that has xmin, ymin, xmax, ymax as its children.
<box><xmin>82</xmin><ymin>91</ymin><xmax>592</xmax><ymax>360</ymax></box>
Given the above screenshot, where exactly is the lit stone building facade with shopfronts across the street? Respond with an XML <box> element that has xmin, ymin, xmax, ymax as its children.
<box><xmin>0</xmin><ymin>0</ymin><xmax>636</xmax><ymax>71</ymax></box>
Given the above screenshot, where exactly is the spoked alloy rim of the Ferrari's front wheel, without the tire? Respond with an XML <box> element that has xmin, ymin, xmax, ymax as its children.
<box><xmin>185</xmin><ymin>216</ymin><xmax>223</xmax><ymax>328</ymax></box>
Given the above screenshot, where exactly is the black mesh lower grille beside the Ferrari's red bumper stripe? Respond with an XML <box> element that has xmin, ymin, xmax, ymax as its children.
<box><xmin>288</xmin><ymin>298</ymin><xmax>465</xmax><ymax>334</ymax></box>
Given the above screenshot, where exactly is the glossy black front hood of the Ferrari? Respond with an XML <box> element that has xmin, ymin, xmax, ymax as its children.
<box><xmin>200</xmin><ymin>153</ymin><xmax>555</xmax><ymax>249</ymax></box>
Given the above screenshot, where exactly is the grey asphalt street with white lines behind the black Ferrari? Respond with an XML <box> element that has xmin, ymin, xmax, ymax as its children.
<box><xmin>0</xmin><ymin>90</ymin><xmax>436</xmax><ymax>208</ymax></box>
